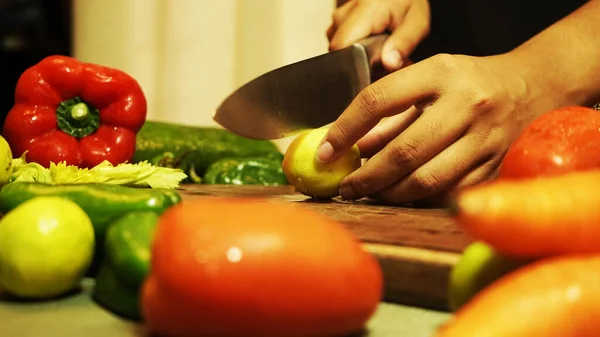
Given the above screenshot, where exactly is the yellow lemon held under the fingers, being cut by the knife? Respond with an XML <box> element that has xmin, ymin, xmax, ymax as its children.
<box><xmin>281</xmin><ymin>127</ymin><xmax>361</xmax><ymax>199</ymax></box>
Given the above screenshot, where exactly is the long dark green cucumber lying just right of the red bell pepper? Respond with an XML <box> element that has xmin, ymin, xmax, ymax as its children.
<box><xmin>132</xmin><ymin>121</ymin><xmax>281</xmax><ymax>182</ymax></box>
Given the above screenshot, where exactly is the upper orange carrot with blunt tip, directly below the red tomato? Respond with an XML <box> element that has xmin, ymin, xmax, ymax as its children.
<box><xmin>455</xmin><ymin>170</ymin><xmax>600</xmax><ymax>256</ymax></box>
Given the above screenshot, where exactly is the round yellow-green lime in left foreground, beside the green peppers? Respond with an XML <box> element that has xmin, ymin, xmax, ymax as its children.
<box><xmin>0</xmin><ymin>196</ymin><xmax>94</xmax><ymax>299</ymax></box>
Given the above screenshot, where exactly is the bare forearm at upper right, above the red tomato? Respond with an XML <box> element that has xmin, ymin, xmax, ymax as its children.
<box><xmin>509</xmin><ymin>0</ymin><xmax>600</xmax><ymax>105</ymax></box>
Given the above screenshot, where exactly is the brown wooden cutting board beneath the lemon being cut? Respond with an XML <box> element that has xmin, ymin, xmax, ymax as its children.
<box><xmin>180</xmin><ymin>184</ymin><xmax>470</xmax><ymax>310</ymax></box>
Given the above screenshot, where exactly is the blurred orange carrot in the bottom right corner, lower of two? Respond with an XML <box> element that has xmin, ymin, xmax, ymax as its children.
<box><xmin>436</xmin><ymin>256</ymin><xmax>600</xmax><ymax>337</ymax></box>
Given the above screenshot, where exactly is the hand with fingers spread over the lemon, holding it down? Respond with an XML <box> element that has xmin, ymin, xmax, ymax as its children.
<box><xmin>317</xmin><ymin>54</ymin><xmax>557</xmax><ymax>204</ymax></box>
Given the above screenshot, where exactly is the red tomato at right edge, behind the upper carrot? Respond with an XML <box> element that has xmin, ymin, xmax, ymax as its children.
<box><xmin>499</xmin><ymin>106</ymin><xmax>600</xmax><ymax>179</ymax></box>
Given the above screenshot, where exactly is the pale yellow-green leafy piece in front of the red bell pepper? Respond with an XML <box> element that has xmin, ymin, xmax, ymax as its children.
<box><xmin>10</xmin><ymin>153</ymin><xmax>187</xmax><ymax>188</ymax></box>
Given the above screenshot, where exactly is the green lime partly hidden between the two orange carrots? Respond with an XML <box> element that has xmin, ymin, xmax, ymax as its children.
<box><xmin>448</xmin><ymin>241</ymin><xmax>531</xmax><ymax>311</ymax></box>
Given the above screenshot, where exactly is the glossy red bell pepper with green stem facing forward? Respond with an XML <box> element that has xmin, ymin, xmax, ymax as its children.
<box><xmin>3</xmin><ymin>56</ymin><xmax>147</xmax><ymax>168</ymax></box>
